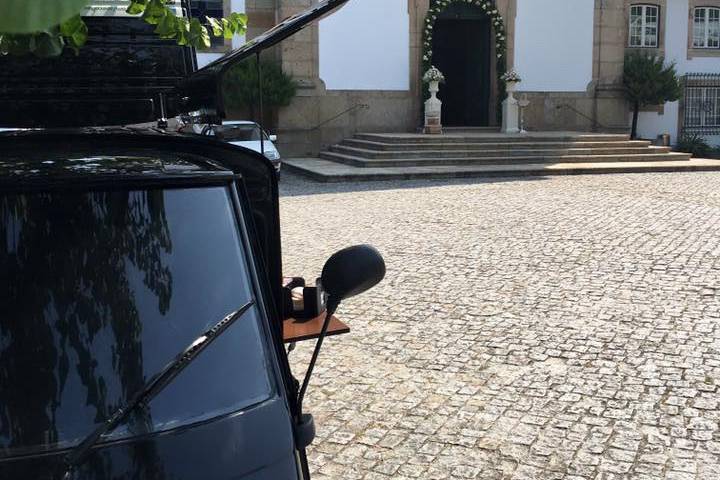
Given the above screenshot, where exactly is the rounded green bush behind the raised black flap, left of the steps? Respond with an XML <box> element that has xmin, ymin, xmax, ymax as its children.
<box><xmin>223</xmin><ymin>58</ymin><xmax>297</xmax><ymax>118</ymax></box>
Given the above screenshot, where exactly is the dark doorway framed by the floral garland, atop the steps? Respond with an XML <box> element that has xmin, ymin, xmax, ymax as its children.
<box><xmin>433</xmin><ymin>18</ymin><xmax>490</xmax><ymax>126</ymax></box>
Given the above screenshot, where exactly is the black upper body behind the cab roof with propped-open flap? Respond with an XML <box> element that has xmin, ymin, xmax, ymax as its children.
<box><xmin>0</xmin><ymin>0</ymin><xmax>348</xmax><ymax>128</ymax></box>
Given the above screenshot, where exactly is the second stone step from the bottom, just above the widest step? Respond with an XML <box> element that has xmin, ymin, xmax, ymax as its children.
<box><xmin>320</xmin><ymin>152</ymin><xmax>690</xmax><ymax>168</ymax></box>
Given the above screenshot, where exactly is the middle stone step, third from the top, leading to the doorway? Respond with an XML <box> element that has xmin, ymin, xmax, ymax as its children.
<box><xmin>330</xmin><ymin>144</ymin><xmax>670</xmax><ymax>160</ymax></box>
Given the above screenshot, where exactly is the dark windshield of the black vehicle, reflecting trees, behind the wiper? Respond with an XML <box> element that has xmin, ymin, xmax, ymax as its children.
<box><xmin>0</xmin><ymin>187</ymin><xmax>271</xmax><ymax>458</ymax></box>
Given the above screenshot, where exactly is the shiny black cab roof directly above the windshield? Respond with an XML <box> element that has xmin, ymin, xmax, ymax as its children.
<box><xmin>0</xmin><ymin>130</ymin><xmax>234</xmax><ymax>190</ymax></box>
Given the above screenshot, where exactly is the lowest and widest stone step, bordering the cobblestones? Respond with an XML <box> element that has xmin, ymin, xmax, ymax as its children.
<box><xmin>283</xmin><ymin>158</ymin><xmax>720</xmax><ymax>182</ymax></box>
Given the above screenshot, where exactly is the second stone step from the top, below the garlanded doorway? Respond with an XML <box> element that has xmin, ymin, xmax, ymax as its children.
<box><xmin>340</xmin><ymin>138</ymin><xmax>651</xmax><ymax>151</ymax></box>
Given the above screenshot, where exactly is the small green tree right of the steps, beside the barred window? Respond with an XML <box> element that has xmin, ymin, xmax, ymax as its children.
<box><xmin>623</xmin><ymin>52</ymin><xmax>682</xmax><ymax>138</ymax></box>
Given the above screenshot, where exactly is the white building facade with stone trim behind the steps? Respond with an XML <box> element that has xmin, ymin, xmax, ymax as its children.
<box><xmin>200</xmin><ymin>0</ymin><xmax>720</xmax><ymax>154</ymax></box>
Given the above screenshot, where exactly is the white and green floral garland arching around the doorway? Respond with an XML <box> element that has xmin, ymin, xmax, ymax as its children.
<box><xmin>422</xmin><ymin>0</ymin><xmax>507</xmax><ymax>120</ymax></box>
